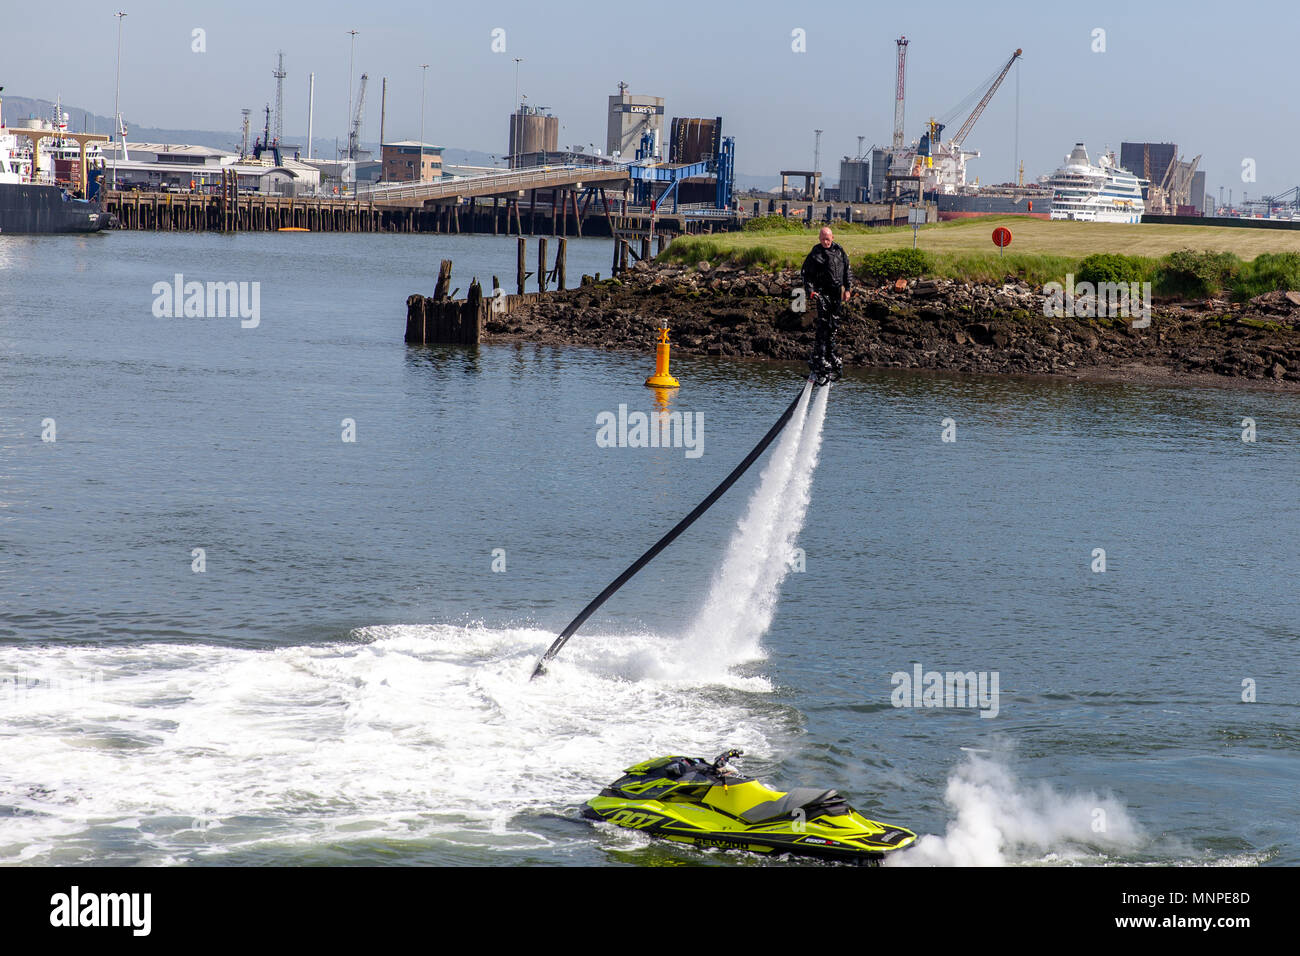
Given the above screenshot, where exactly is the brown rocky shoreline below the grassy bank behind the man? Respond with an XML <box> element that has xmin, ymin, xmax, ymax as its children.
<box><xmin>482</xmin><ymin>263</ymin><xmax>1300</xmax><ymax>392</ymax></box>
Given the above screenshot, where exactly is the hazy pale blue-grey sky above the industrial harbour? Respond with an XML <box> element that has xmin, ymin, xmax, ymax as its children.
<box><xmin>0</xmin><ymin>0</ymin><xmax>1300</xmax><ymax>199</ymax></box>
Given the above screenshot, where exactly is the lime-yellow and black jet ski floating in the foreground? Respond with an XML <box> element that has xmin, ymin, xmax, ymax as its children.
<box><xmin>582</xmin><ymin>749</ymin><xmax>917</xmax><ymax>864</ymax></box>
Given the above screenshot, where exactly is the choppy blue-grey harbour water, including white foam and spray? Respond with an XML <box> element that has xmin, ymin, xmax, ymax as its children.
<box><xmin>0</xmin><ymin>233</ymin><xmax>1300</xmax><ymax>865</ymax></box>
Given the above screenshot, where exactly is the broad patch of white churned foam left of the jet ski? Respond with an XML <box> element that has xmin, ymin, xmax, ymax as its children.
<box><xmin>0</xmin><ymin>626</ymin><xmax>787</xmax><ymax>865</ymax></box>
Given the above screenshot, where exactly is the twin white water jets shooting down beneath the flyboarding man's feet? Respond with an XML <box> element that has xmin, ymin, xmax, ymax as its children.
<box><xmin>688</xmin><ymin>385</ymin><xmax>829</xmax><ymax>666</ymax></box>
